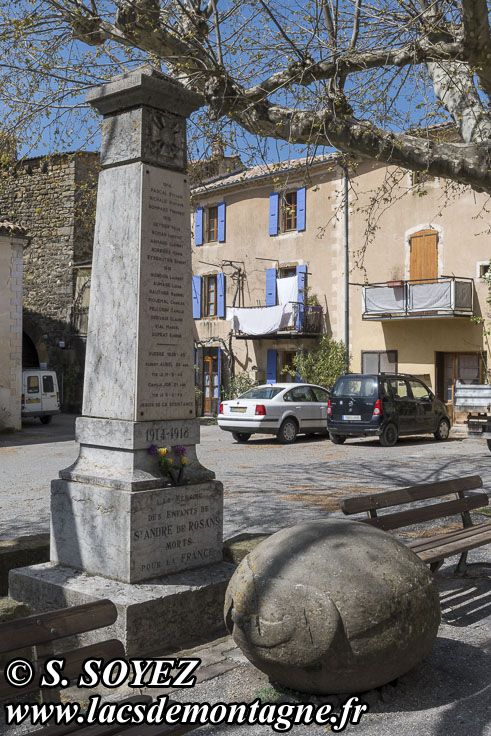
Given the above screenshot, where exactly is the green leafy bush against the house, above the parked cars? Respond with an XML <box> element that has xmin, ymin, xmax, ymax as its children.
<box><xmin>285</xmin><ymin>335</ymin><xmax>348</xmax><ymax>390</ymax></box>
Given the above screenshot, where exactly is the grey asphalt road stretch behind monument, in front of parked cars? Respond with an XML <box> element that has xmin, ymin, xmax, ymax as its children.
<box><xmin>0</xmin><ymin>415</ymin><xmax>491</xmax><ymax>539</ymax></box>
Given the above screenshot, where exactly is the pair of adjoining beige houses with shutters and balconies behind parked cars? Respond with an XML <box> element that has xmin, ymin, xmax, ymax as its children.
<box><xmin>192</xmin><ymin>154</ymin><xmax>491</xmax><ymax>419</ymax></box>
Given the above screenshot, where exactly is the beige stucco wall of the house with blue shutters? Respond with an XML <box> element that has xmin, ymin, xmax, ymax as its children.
<box><xmin>192</xmin><ymin>165</ymin><xmax>343</xmax><ymax>380</ymax></box>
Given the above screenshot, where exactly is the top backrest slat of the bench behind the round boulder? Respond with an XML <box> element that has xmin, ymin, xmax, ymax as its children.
<box><xmin>341</xmin><ymin>475</ymin><xmax>487</xmax><ymax>515</ymax></box>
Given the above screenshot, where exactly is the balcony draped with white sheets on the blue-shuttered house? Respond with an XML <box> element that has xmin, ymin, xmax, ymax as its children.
<box><xmin>232</xmin><ymin>302</ymin><xmax>324</xmax><ymax>340</ymax></box>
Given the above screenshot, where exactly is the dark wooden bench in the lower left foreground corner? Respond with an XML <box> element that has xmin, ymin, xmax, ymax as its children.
<box><xmin>0</xmin><ymin>600</ymin><xmax>198</xmax><ymax>736</ymax></box>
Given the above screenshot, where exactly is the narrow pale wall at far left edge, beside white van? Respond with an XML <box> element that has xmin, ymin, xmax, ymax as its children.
<box><xmin>0</xmin><ymin>235</ymin><xmax>24</xmax><ymax>430</ymax></box>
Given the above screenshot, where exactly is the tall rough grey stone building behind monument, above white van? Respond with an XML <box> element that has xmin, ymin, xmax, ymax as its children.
<box><xmin>0</xmin><ymin>152</ymin><xmax>99</xmax><ymax>408</ymax></box>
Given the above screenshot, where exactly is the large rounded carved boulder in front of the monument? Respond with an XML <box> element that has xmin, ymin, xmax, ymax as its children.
<box><xmin>225</xmin><ymin>519</ymin><xmax>440</xmax><ymax>694</ymax></box>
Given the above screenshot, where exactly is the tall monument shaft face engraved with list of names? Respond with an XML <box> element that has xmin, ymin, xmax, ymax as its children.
<box><xmin>136</xmin><ymin>166</ymin><xmax>195</xmax><ymax>421</ymax></box>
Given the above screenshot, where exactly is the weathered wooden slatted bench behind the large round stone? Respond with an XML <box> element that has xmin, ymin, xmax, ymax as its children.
<box><xmin>341</xmin><ymin>475</ymin><xmax>491</xmax><ymax>574</ymax></box>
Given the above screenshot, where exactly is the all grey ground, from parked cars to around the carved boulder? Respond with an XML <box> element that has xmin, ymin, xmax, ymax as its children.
<box><xmin>0</xmin><ymin>417</ymin><xmax>491</xmax><ymax>736</ymax></box>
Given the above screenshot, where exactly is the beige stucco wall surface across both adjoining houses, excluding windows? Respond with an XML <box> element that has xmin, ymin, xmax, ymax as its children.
<box><xmin>193</xmin><ymin>162</ymin><xmax>491</xmax><ymax>400</ymax></box>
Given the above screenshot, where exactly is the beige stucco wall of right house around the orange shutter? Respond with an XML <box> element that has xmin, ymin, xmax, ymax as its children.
<box><xmin>350</xmin><ymin>165</ymin><xmax>491</xmax><ymax>388</ymax></box>
